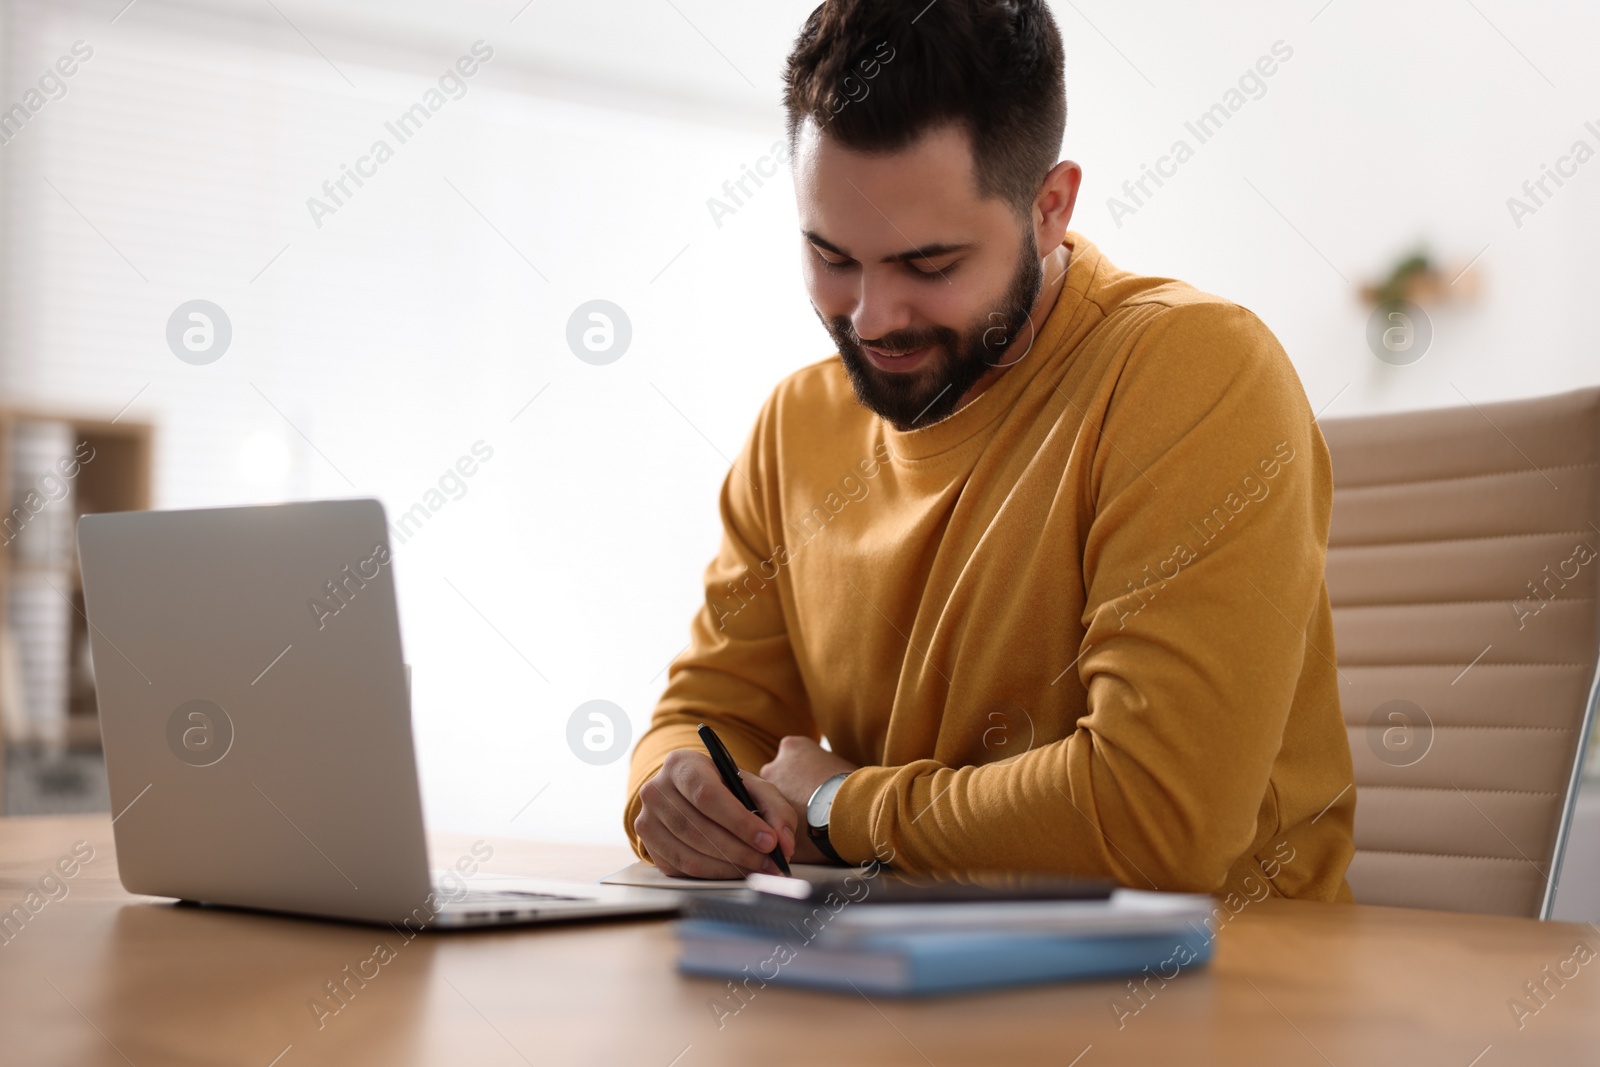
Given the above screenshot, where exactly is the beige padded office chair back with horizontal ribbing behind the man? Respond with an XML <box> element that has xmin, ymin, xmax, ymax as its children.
<box><xmin>1322</xmin><ymin>389</ymin><xmax>1600</xmax><ymax>918</ymax></box>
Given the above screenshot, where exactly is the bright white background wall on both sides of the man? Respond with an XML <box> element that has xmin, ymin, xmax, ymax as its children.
<box><xmin>0</xmin><ymin>0</ymin><xmax>1600</xmax><ymax>840</ymax></box>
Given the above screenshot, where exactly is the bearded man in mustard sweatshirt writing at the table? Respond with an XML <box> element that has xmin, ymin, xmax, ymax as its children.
<box><xmin>626</xmin><ymin>0</ymin><xmax>1355</xmax><ymax>901</ymax></box>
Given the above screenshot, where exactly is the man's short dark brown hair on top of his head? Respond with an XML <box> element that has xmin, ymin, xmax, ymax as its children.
<box><xmin>784</xmin><ymin>0</ymin><xmax>1067</xmax><ymax>213</ymax></box>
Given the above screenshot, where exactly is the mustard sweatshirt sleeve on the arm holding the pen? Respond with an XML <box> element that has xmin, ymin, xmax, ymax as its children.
<box><xmin>622</xmin><ymin>394</ymin><xmax>821</xmax><ymax>859</ymax></box>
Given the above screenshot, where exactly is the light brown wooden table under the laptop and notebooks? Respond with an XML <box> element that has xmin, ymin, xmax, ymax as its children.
<box><xmin>0</xmin><ymin>816</ymin><xmax>1600</xmax><ymax>1067</ymax></box>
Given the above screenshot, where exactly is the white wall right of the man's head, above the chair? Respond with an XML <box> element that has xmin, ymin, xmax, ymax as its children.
<box><xmin>1056</xmin><ymin>0</ymin><xmax>1600</xmax><ymax>416</ymax></box>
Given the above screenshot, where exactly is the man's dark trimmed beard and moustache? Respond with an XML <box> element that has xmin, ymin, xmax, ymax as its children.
<box><xmin>818</xmin><ymin>230</ymin><xmax>1045</xmax><ymax>432</ymax></box>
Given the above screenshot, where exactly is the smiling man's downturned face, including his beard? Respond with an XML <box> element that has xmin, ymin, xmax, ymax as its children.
<box><xmin>795</xmin><ymin>122</ymin><xmax>1043</xmax><ymax>430</ymax></box>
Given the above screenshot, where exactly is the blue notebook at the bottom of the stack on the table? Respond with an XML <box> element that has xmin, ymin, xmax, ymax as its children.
<box><xmin>678</xmin><ymin>920</ymin><xmax>1211</xmax><ymax>995</ymax></box>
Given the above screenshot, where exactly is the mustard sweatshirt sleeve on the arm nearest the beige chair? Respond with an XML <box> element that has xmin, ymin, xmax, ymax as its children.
<box><xmin>830</xmin><ymin>302</ymin><xmax>1333</xmax><ymax>891</ymax></box>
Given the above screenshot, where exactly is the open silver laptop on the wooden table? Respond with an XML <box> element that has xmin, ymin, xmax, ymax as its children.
<box><xmin>78</xmin><ymin>501</ymin><xmax>678</xmax><ymax>929</ymax></box>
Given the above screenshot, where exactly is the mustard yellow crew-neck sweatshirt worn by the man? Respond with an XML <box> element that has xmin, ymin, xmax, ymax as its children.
<box><xmin>624</xmin><ymin>234</ymin><xmax>1355</xmax><ymax>901</ymax></box>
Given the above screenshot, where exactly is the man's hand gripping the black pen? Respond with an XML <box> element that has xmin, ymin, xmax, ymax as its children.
<box><xmin>634</xmin><ymin>749</ymin><xmax>800</xmax><ymax>878</ymax></box>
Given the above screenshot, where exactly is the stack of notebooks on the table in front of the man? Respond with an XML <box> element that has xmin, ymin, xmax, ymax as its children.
<box><xmin>678</xmin><ymin>875</ymin><xmax>1213</xmax><ymax>993</ymax></box>
